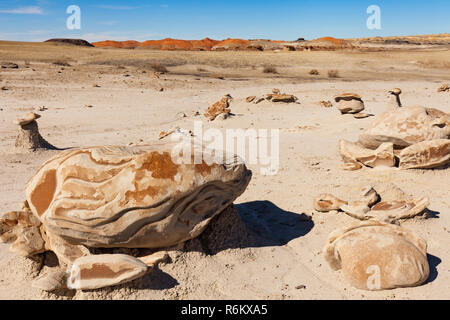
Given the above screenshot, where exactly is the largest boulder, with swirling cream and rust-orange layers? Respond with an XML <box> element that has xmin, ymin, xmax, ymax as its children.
<box><xmin>25</xmin><ymin>142</ymin><xmax>251</xmax><ymax>248</ymax></box>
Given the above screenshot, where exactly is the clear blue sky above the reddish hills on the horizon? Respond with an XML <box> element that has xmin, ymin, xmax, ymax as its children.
<box><xmin>0</xmin><ymin>0</ymin><xmax>450</xmax><ymax>41</ymax></box>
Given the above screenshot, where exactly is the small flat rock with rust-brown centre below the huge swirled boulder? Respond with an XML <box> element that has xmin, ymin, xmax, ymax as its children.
<box><xmin>68</xmin><ymin>254</ymin><xmax>147</xmax><ymax>290</ymax></box>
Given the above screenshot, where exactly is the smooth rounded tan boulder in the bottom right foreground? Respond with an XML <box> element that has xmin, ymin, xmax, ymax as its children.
<box><xmin>324</xmin><ymin>221</ymin><xmax>430</xmax><ymax>290</ymax></box>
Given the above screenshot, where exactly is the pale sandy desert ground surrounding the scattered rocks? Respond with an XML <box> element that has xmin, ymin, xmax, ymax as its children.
<box><xmin>0</xmin><ymin>42</ymin><xmax>450</xmax><ymax>299</ymax></box>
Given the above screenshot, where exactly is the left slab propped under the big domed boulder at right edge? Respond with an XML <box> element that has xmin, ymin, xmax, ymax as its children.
<box><xmin>339</xmin><ymin>140</ymin><xmax>395</xmax><ymax>168</ymax></box>
